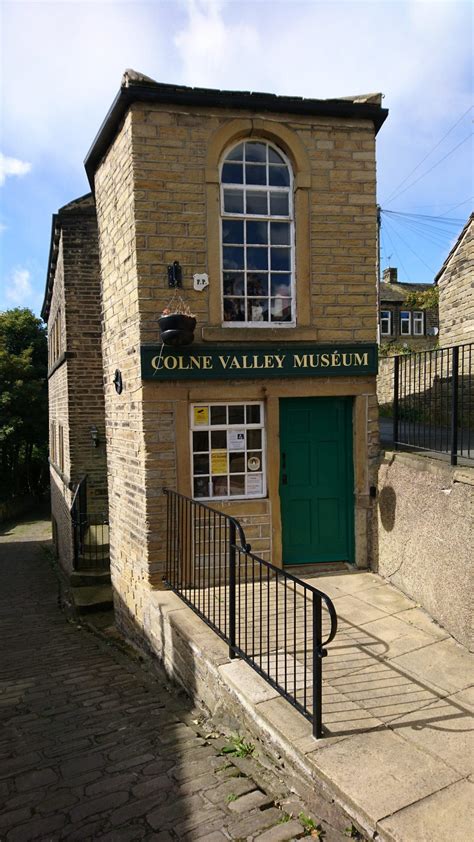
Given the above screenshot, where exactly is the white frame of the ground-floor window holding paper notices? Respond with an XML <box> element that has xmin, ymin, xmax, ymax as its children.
<box><xmin>189</xmin><ymin>400</ymin><xmax>267</xmax><ymax>502</ymax></box>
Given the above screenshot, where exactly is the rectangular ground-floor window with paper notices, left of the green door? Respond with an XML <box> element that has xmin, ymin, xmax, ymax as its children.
<box><xmin>190</xmin><ymin>401</ymin><xmax>267</xmax><ymax>500</ymax></box>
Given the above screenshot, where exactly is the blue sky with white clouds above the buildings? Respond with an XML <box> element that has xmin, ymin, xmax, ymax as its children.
<box><xmin>0</xmin><ymin>0</ymin><xmax>474</xmax><ymax>314</ymax></box>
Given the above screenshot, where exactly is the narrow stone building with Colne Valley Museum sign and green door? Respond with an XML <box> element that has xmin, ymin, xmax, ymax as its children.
<box><xmin>45</xmin><ymin>71</ymin><xmax>387</xmax><ymax>635</ymax></box>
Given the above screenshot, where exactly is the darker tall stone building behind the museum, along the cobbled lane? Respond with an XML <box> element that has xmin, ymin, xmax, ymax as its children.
<box><xmin>41</xmin><ymin>194</ymin><xmax>107</xmax><ymax>573</ymax></box>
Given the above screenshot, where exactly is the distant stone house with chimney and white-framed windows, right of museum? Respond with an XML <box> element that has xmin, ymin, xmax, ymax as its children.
<box><xmin>379</xmin><ymin>267</ymin><xmax>439</xmax><ymax>352</ymax></box>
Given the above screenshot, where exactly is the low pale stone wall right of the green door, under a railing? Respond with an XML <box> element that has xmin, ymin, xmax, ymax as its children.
<box><xmin>377</xmin><ymin>453</ymin><xmax>474</xmax><ymax>649</ymax></box>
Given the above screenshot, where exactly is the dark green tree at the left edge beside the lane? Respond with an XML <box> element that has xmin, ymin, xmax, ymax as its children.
<box><xmin>0</xmin><ymin>307</ymin><xmax>48</xmax><ymax>500</ymax></box>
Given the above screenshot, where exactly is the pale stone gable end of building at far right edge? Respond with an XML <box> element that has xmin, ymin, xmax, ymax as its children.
<box><xmin>435</xmin><ymin>213</ymin><xmax>474</xmax><ymax>347</ymax></box>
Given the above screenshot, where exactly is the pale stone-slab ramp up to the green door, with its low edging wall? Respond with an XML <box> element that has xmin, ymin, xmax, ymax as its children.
<box><xmin>149</xmin><ymin>569</ymin><xmax>474</xmax><ymax>842</ymax></box>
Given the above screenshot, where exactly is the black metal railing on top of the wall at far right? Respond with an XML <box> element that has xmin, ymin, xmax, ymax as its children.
<box><xmin>393</xmin><ymin>343</ymin><xmax>474</xmax><ymax>465</ymax></box>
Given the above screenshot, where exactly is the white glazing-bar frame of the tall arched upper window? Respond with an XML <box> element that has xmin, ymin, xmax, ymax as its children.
<box><xmin>219</xmin><ymin>136</ymin><xmax>296</xmax><ymax>329</ymax></box>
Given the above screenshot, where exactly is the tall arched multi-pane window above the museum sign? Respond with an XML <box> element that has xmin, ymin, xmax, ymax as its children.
<box><xmin>220</xmin><ymin>140</ymin><xmax>295</xmax><ymax>327</ymax></box>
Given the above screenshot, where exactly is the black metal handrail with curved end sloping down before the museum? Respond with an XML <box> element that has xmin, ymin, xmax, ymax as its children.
<box><xmin>164</xmin><ymin>488</ymin><xmax>337</xmax><ymax>737</ymax></box>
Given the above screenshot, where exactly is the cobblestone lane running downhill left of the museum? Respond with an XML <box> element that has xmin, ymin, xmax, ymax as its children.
<box><xmin>0</xmin><ymin>522</ymin><xmax>356</xmax><ymax>842</ymax></box>
